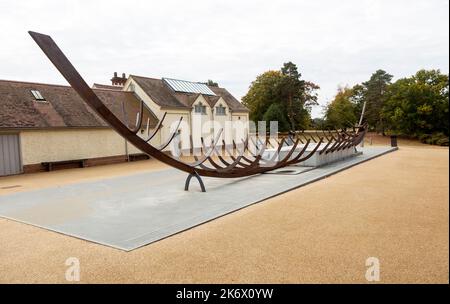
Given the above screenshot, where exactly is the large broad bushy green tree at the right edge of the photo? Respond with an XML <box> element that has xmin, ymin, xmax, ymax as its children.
<box><xmin>382</xmin><ymin>70</ymin><xmax>449</xmax><ymax>137</ymax></box>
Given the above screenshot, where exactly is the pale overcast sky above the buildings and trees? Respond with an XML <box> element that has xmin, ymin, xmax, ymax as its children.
<box><xmin>0</xmin><ymin>0</ymin><xmax>449</xmax><ymax>117</ymax></box>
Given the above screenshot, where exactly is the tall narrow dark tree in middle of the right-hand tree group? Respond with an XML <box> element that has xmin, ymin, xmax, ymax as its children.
<box><xmin>362</xmin><ymin>70</ymin><xmax>392</xmax><ymax>134</ymax></box>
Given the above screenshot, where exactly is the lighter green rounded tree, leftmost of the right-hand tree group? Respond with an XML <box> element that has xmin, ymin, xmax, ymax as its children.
<box><xmin>325</xmin><ymin>87</ymin><xmax>358</xmax><ymax>129</ymax></box>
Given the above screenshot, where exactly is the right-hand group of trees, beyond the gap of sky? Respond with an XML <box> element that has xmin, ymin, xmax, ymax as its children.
<box><xmin>322</xmin><ymin>70</ymin><xmax>449</xmax><ymax>145</ymax></box>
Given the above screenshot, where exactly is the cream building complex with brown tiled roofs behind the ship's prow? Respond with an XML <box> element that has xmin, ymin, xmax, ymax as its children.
<box><xmin>0</xmin><ymin>73</ymin><xmax>248</xmax><ymax>176</ymax></box>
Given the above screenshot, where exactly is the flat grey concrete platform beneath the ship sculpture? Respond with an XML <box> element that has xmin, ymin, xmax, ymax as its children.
<box><xmin>0</xmin><ymin>147</ymin><xmax>396</xmax><ymax>251</ymax></box>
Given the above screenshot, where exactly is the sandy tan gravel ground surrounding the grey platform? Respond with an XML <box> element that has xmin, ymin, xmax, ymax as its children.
<box><xmin>0</xmin><ymin>144</ymin><xmax>449</xmax><ymax>283</ymax></box>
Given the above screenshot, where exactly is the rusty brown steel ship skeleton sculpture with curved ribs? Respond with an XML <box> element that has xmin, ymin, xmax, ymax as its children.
<box><xmin>29</xmin><ymin>31</ymin><xmax>367</xmax><ymax>192</ymax></box>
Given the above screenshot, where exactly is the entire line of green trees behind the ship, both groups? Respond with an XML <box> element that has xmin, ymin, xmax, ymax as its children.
<box><xmin>242</xmin><ymin>62</ymin><xmax>449</xmax><ymax>145</ymax></box>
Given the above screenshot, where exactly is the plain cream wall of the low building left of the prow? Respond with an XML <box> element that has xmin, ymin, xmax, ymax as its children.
<box><xmin>20</xmin><ymin>129</ymin><xmax>142</xmax><ymax>165</ymax></box>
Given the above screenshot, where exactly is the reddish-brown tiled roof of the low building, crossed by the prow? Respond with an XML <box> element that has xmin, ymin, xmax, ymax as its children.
<box><xmin>0</xmin><ymin>80</ymin><xmax>157</xmax><ymax>129</ymax></box>
